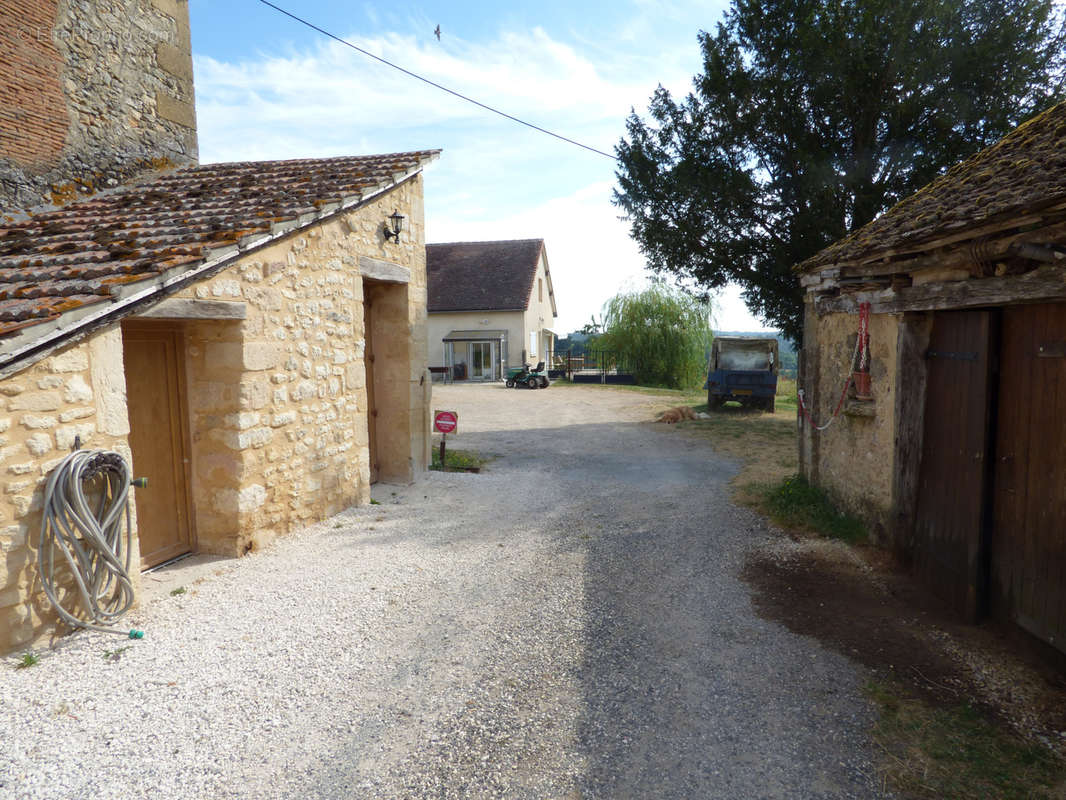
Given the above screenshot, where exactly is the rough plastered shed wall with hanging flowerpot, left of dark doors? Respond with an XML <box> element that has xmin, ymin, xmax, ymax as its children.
<box><xmin>801</xmin><ymin>314</ymin><xmax>900</xmax><ymax>538</ymax></box>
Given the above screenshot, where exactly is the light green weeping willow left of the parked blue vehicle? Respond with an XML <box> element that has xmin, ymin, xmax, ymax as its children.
<box><xmin>597</xmin><ymin>282</ymin><xmax>712</xmax><ymax>389</ymax></box>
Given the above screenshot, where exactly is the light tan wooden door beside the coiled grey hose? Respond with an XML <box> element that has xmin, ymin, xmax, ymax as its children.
<box><xmin>123</xmin><ymin>322</ymin><xmax>193</xmax><ymax>569</ymax></box>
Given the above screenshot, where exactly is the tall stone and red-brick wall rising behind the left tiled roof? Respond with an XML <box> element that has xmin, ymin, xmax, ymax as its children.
<box><xmin>0</xmin><ymin>0</ymin><xmax>197</xmax><ymax>214</ymax></box>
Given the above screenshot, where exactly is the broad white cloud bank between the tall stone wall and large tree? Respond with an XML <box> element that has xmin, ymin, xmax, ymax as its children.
<box><xmin>195</xmin><ymin>6</ymin><xmax>757</xmax><ymax>333</ymax></box>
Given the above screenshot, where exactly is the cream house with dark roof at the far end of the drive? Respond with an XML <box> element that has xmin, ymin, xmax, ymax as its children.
<box><xmin>425</xmin><ymin>239</ymin><xmax>559</xmax><ymax>381</ymax></box>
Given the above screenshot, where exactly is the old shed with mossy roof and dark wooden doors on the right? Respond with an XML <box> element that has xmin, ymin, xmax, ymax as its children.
<box><xmin>798</xmin><ymin>98</ymin><xmax>1066</xmax><ymax>647</ymax></box>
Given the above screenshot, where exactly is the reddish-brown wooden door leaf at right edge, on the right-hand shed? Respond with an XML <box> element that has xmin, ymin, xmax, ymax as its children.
<box><xmin>991</xmin><ymin>303</ymin><xmax>1066</xmax><ymax>650</ymax></box>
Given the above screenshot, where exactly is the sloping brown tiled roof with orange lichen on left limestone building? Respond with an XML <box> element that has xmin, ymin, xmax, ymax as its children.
<box><xmin>0</xmin><ymin>150</ymin><xmax>439</xmax><ymax>350</ymax></box>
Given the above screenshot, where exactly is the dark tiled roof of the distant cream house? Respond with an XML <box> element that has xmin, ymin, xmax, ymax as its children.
<box><xmin>425</xmin><ymin>239</ymin><xmax>544</xmax><ymax>311</ymax></box>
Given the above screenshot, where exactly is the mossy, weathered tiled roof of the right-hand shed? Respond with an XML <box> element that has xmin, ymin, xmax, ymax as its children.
<box><xmin>797</xmin><ymin>102</ymin><xmax>1066</xmax><ymax>272</ymax></box>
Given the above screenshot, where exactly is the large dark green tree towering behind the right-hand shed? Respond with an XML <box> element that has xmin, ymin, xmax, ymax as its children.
<box><xmin>615</xmin><ymin>0</ymin><xmax>1066</xmax><ymax>341</ymax></box>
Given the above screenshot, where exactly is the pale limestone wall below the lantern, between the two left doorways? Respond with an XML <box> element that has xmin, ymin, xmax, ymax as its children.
<box><xmin>170</xmin><ymin>177</ymin><xmax>430</xmax><ymax>555</ymax></box>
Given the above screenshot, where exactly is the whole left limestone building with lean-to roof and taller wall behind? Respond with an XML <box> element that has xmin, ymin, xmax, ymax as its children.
<box><xmin>0</xmin><ymin>0</ymin><xmax>438</xmax><ymax>652</ymax></box>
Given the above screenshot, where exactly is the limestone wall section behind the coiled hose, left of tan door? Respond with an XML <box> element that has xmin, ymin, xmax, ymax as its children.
<box><xmin>0</xmin><ymin>325</ymin><xmax>140</xmax><ymax>653</ymax></box>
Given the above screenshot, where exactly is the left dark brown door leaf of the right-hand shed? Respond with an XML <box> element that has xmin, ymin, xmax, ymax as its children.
<box><xmin>915</xmin><ymin>311</ymin><xmax>991</xmax><ymax>620</ymax></box>
